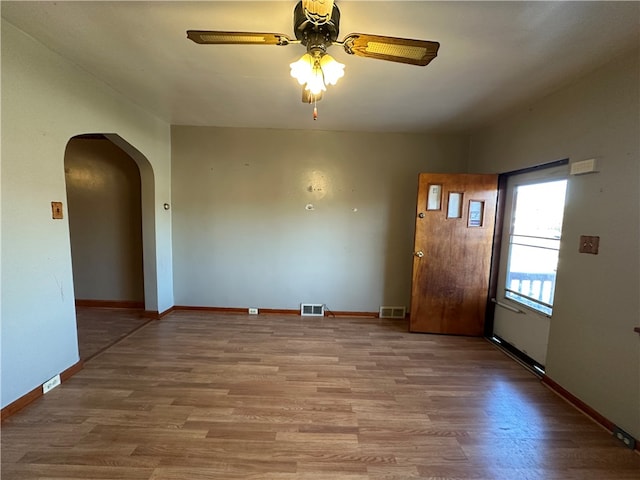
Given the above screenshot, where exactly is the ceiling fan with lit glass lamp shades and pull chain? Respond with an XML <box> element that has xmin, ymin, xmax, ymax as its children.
<box><xmin>187</xmin><ymin>0</ymin><xmax>440</xmax><ymax>120</ymax></box>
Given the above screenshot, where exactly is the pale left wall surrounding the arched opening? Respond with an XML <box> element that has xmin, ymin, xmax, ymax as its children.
<box><xmin>0</xmin><ymin>20</ymin><xmax>173</xmax><ymax>407</ymax></box>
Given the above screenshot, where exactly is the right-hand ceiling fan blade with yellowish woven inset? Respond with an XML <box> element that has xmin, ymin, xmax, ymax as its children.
<box><xmin>342</xmin><ymin>33</ymin><xmax>440</xmax><ymax>66</ymax></box>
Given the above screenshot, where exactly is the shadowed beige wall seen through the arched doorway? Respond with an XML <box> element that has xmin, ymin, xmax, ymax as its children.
<box><xmin>64</xmin><ymin>138</ymin><xmax>144</xmax><ymax>302</ymax></box>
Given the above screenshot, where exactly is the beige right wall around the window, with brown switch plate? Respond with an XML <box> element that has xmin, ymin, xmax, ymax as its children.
<box><xmin>470</xmin><ymin>51</ymin><xmax>640</xmax><ymax>438</ymax></box>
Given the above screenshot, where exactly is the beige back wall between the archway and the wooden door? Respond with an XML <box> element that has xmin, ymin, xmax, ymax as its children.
<box><xmin>172</xmin><ymin>126</ymin><xmax>467</xmax><ymax>312</ymax></box>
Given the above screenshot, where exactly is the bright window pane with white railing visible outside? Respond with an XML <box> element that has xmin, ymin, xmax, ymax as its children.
<box><xmin>505</xmin><ymin>179</ymin><xmax>567</xmax><ymax>316</ymax></box>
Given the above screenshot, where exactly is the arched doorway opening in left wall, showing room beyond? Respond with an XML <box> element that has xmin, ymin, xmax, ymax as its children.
<box><xmin>64</xmin><ymin>134</ymin><xmax>155</xmax><ymax>360</ymax></box>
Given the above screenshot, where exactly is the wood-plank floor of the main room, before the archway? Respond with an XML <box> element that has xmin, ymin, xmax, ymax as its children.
<box><xmin>1</xmin><ymin>311</ymin><xmax>640</xmax><ymax>480</ymax></box>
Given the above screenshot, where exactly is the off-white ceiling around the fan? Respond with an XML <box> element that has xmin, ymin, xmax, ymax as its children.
<box><xmin>2</xmin><ymin>0</ymin><xmax>640</xmax><ymax>132</ymax></box>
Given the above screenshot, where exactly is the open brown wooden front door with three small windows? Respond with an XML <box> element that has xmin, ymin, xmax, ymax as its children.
<box><xmin>409</xmin><ymin>173</ymin><xmax>498</xmax><ymax>336</ymax></box>
